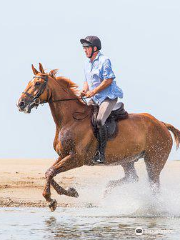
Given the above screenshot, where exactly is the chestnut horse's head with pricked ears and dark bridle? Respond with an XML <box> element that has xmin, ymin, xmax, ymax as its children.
<box><xmin>17</xmin><ymin>63</ymin><xmax>54</xmax><ymax>113</ymax></box>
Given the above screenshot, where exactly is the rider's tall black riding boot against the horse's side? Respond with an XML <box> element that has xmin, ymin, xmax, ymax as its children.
<box><xmin>94</xmin><ymin>125</ymin><xmax>107</xmax><ymax>163</ymax></box>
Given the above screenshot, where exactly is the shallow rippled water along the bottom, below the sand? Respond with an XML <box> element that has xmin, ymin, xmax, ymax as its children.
<box><xmin>0</xmin><ymin>207</ymin><xmax>180</xmax><ymax>240</ymax></box>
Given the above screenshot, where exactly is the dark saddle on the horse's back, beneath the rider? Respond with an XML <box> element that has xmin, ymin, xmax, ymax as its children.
<box><xmin>91</xmin><ymin>102</ymin><xmax>128</xmax><ymax>140</ymax></box>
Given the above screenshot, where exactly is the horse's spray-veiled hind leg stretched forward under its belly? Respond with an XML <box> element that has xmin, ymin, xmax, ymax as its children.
<box><xmin>106</xmin><ymin>162</ymin><xmax>139</xmax><ymax>193</ymax></box>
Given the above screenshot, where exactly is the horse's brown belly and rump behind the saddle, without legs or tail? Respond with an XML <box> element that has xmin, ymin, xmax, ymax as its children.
<box><xmin>103</xmin><ymin>114</ymin><xmax>172</xmax><ymax>164</ymax></box>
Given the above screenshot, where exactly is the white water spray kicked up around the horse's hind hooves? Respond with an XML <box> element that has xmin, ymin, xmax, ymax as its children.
<box><xmin>99</xmin><ymin>175</ymin><xmax>180</xmax><ymax>217</ymax></box>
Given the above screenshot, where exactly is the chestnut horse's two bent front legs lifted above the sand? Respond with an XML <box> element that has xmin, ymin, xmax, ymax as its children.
<box><xmin>43</xmin><ymin>154</ymin><xmax>83</xmax><ymax>211</ymax></box>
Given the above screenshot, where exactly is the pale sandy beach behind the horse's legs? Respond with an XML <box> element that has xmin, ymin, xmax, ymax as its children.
<box><xmin>0</xmin><ymin>159</ymin><xmax>180</xmax><ymax>207</ymax></box>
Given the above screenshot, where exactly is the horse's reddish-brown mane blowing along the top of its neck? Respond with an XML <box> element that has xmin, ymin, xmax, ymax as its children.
<box><xmin>49</xmin><ymin>69</ymin><xmax>84</xmax><ymax>103</ymax></box>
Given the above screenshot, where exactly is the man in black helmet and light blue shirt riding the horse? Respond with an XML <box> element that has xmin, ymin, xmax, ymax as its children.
<box><xmin>80</xmin><ymin>36</ymin><xmax>123</xmax><ymax>163</ymax></box>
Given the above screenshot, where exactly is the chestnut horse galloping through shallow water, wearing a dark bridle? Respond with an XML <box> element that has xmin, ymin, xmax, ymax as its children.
<box><xmin>17</xmin><ymin>63</ymin><xmax>180</xmax><ymax>211</ymax></box>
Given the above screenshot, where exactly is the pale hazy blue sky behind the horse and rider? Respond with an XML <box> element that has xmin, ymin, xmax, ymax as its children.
<box><xmin>0</xmin><ymin>0</ymin><xmax>180</xmax><ymax>159</ymax></box>
